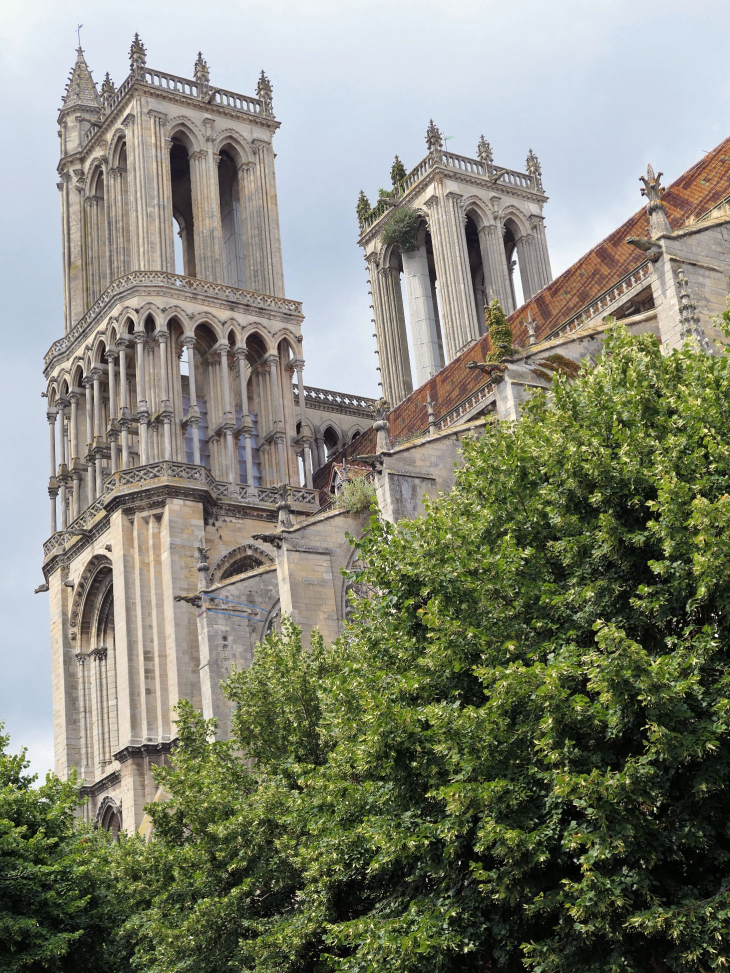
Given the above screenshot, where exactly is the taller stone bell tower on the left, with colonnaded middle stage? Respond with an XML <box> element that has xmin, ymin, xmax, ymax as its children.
<box><xmin>41</xmin><ymin>35</ymin><xmax>317</xmax><ymax>831</ymax></box>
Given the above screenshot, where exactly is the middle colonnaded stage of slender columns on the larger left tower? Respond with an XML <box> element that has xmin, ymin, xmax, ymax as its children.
<box><xmin>47</xmin><ymin>310</ymin><xmax>312</xmax><ymax>533</ymax></box>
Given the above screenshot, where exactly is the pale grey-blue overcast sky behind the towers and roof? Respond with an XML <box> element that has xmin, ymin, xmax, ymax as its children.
<box><xmin>0</xmin><ymin>0</ymin><xmax>730</xmax><ymax>772</ymax></box>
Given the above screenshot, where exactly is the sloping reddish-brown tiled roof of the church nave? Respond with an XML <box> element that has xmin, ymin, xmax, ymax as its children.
<box><xmin>315</xmin><ymin>138</ymin><xmax>730</xmax><ymax>488</ymax></box>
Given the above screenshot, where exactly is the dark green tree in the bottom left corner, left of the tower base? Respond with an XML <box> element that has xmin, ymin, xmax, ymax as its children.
<box><xmin>0</xmin><ymin>725</ymin><xmax>126</xmax><ymax>973</ymax></box>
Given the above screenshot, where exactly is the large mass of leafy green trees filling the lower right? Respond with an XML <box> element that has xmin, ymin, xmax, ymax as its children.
<box><xmin>12</xmin><ymin>329</ymin><xmax>730</xmax><ymax>973</ymax></box>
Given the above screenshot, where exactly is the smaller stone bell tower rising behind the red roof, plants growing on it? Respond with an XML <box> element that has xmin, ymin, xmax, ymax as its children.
<box><xmin>357</xmin><ymin>121</ymin><xmax>552</xmax><ymax>405</ymax></box>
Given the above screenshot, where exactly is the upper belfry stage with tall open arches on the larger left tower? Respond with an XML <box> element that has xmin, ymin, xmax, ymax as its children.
<box><xmin>74</xmin><ymin>117</ymin><xmax>283</xmax><ymax>321</ymax></box>
